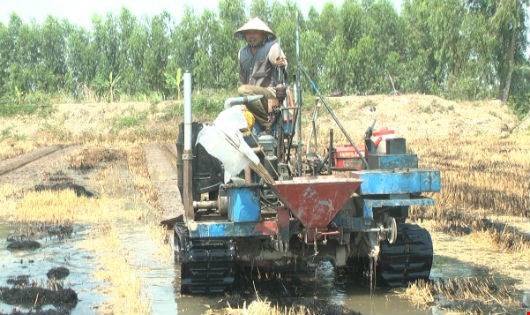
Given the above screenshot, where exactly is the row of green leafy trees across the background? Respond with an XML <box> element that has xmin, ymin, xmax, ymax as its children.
<box><xmin>0</xmin><ymin>0</ymin><xmax>530</xmax><ymax>113</ymax></box>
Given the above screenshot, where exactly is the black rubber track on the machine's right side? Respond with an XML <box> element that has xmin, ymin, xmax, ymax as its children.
<box><xmin>377</xmin><ymin>224</ymin><xmax>433</xmax><ymax>287</ymax></box>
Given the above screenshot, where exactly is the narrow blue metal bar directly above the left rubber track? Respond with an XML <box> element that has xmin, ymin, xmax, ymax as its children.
<box><xmin>188</xmin><ymin>221</ymin><xmax>278</xmax><ymax>238</ymax></box>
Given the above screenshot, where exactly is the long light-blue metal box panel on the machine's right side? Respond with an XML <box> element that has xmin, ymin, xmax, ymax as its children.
<box><xmin>352</xmin><ymin>169</ymin><xmax>441</xmax><ymax>195</ymax></box>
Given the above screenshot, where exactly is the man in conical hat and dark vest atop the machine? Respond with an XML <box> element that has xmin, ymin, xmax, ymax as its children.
<box><xmin>235</xmin><ymin>17</ymin><xmax>287</xmax><ymax>129</ymax></box>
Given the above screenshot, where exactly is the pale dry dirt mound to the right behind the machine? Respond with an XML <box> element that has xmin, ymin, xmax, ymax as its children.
<box><xmin>316</xmin><ymin>94</ymin><xmax>519</xmax><ymax>139</ymax></box>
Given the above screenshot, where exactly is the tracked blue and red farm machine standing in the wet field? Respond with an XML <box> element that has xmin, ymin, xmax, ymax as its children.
<box><xmin>166</xmin><ymin>68</ymin><xmax>440</xmax><ymax>294</ymax></box>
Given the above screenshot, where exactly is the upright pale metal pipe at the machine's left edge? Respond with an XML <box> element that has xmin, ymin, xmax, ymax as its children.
<box><xmin>182</xmin><ymin>71</ymin><xmax>195</xmax><ymax>221</ymax></box>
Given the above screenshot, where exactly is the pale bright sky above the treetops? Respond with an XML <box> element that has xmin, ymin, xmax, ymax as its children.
<box><xmin>0</xmin><ymin>0</ymin><xmax>402</xmax><ymax>28</ymax></box>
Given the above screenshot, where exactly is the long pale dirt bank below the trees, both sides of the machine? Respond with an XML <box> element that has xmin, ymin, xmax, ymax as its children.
<box><xmin>0</xmin><ymin>94</ymin><xmax>528</xmax><ymax>149</ymax></box>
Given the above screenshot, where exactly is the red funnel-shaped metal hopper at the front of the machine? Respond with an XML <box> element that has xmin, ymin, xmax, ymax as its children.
<box><xmin>272</xmin><ymin>176</ymin><xmax>362</xmax><ymax>228</ymax></box>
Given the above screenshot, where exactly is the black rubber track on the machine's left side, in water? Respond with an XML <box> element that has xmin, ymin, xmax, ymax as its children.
<box><xmin>175</xmin><ymin>228</ymin><xmax>236</xmax><ymax>294</ymax></box>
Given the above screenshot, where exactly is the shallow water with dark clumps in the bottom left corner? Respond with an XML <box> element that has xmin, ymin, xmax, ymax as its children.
<box><xmin>0</xmin><ymin>220</ymin><xmax>105</xmax><ymax>314</ymax></box>
